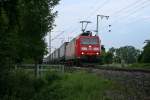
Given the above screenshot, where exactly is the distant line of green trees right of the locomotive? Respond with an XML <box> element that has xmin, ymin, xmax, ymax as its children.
<box><xmin>101</xmin><ymin>40</ymin><xmax>150</xmax><ymax>64</ymax></box>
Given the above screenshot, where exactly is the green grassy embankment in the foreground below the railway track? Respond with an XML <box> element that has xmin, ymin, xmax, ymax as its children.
<box><xmin>0</xmin><ymin>71</ymin><xmax>136</xmax><ymax>100</ymax></box>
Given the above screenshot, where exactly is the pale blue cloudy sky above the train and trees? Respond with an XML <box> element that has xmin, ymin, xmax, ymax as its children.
<box><xmin>46</xmin><ymin>0</ymin><xmax>150</xmax><ymax>51</ymax></box>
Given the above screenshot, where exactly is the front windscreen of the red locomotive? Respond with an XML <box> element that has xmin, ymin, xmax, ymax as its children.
<box><xmin>81</xmin><ymin>38</ymin><xmax>98</xmax><ymax>44</ymax></box>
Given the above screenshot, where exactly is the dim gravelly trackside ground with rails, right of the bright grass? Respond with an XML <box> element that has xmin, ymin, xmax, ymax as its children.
<box><xmin>70</xmin><ymin>67</ymin><xmax>150</xmax><ymax>100</ymax></box>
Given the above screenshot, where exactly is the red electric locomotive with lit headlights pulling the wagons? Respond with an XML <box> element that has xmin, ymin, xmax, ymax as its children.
<box><xmin>65</xmin><ymin>31</ymin><xmax>101</xmax><ymax>64</ymax></box>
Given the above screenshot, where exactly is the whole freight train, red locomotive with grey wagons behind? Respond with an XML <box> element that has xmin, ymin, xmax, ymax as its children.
<box><xmin>45</xmin><ymin>31</ymin><xmax>101</xmax><ymax>65</ymax></box>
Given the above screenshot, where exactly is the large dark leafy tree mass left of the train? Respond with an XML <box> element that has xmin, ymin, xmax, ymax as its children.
<box><xmin>0</xmin><ymin>0</ymin><xmax>59</xmax><ymax>70</ymax></box>
